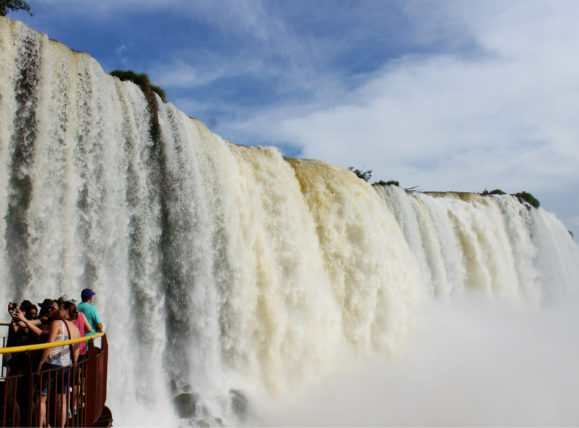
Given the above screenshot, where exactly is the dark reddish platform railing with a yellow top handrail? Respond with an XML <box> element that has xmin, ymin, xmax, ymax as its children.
<box><xmin>0</xmin><ymin>332</ymin><xmax>108</xmax><ymax>427</ymax></box>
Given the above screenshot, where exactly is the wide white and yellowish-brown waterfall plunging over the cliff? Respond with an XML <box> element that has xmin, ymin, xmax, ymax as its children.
<box><xmin>0</xmin><ymin>18</ymin><xmax>579</xmax><ymax>426</ymax></box>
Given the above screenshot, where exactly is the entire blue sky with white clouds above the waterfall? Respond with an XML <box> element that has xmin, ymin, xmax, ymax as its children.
<box><xmin>9</xmin><ymin>0</ymin><xmax>579</xmax><ymax>236</ymax></box>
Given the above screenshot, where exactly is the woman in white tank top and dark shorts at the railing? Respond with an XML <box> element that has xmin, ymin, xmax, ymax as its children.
<box><xmin>38</xmin><ymin>301</ymin><xmax>80</xmax><ymax>426</ymax></box>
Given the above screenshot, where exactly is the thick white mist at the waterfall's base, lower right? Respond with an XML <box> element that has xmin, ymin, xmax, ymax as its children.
<box><xmin>257</xmin><ymin>295</ymin><xmax>579</xmax><ymax>426</ymax></box>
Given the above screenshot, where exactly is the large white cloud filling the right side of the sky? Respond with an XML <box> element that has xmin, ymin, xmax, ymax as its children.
<box><xmin>225</xmin><ymin>2</ymin><xmax>579</xmax><ymax>232</ymax></box>
